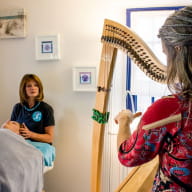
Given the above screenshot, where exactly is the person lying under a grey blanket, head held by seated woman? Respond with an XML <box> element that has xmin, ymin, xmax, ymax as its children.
<box><xmin>0</xmin><ymin>121</ymin><xmax>43</xmax><ymax>192</ymax></box>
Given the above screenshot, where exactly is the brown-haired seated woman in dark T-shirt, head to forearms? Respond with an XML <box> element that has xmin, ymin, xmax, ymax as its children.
<box><xmin>11</xmin><ymin>74</ymin><xmax>55</xmax><ymax>144</ymax></box>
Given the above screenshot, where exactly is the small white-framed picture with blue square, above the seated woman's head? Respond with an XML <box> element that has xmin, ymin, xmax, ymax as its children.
<box><xmin>35</xmin><ymin>34</ymin><xmax>60</xmax><ymax>60</ymax></box>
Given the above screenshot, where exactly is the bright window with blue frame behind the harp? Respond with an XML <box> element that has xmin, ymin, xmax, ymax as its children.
<box><xmin>126</xmin><ymin>6</ymin><xmax>182</xmax><ymax>115</ymax></box>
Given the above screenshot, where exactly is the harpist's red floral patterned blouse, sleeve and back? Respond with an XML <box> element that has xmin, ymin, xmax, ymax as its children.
<box><xmin>118</xmin><ymin>95</ymin><xmax>192</xmax><ymax>192</ymax></box>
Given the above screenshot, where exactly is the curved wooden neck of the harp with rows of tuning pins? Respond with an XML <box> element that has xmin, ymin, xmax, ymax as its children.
<box><xmin>101</xmin><ymin>19</ymin><xmax>166</xmax><ymax>83</ymax></box>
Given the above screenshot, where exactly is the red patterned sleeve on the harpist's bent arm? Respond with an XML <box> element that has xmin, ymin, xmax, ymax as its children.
<box><xmin>118</xmin><ymin>97</ymin><xmax>179</xmax><ymax>167</ymax></box>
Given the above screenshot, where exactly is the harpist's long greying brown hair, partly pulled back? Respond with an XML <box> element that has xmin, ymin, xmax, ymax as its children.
<box><xmin>158</xmin><ymin>6</ymin><xmax>192</xmax><ymax>97</ymax></box>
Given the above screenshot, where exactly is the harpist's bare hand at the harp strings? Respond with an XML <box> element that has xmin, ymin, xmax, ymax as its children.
<box><xmin>114</xmin><ymin>110</ymin><xmax>142</xmax><ymax>124</ymax></box>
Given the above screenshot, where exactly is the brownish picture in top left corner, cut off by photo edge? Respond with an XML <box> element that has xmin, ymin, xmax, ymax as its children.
<box><xmin>0</xmin><ymin>8</ymin><xmax>26</xmax><ymax>39</ymax></box>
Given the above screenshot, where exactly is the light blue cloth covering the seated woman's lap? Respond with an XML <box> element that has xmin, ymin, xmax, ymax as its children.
<box><xmin>26</xmin><ymin>139</ymin><xmax>55</xmax><ymax>166</ymax></box>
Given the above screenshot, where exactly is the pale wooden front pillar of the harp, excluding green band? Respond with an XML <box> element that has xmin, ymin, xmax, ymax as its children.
<box><xmin>91</xmin><ymin>44</ymin><xmax>117</xmax><ymax>192</ymax></box>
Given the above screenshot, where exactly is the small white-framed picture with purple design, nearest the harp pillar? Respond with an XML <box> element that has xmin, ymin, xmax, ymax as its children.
<box><xmin>73</xmin><ymin>67</ymin><xmax>96</xmax><ymax>91</ymax></box>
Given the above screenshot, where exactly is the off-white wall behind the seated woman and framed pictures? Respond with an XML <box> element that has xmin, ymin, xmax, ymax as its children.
<box><xmin>0</xmin><ymin>0</ymin><xmax>191</xmax><ymax>192</ymax></box>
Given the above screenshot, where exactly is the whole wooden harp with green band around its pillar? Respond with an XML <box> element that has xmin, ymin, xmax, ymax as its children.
<box><xmin>91</xmin><ymin>19</ymin><xmax>180</xmax><ymax>192</ymax></box>
